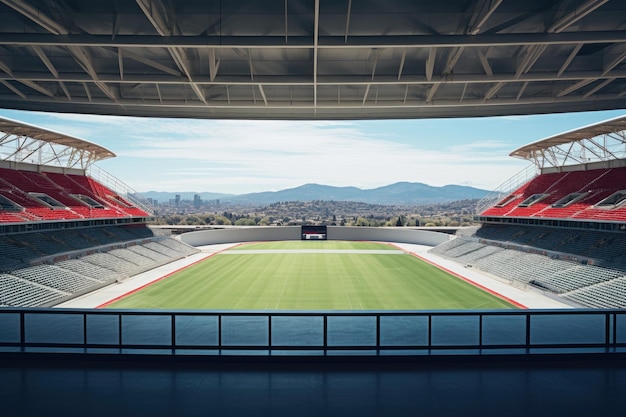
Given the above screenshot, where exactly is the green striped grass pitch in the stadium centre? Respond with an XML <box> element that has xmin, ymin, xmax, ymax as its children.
<box><xmin>109</xmin><ymin>241</ymin><xmax>514</xmax><ymax>310</ymax></box>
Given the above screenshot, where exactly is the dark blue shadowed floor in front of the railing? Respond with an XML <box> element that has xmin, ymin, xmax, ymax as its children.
<box><xmin>0</xmin><ymin>359</ymin><xmax>626</xmax><ymax>417</ymax></box>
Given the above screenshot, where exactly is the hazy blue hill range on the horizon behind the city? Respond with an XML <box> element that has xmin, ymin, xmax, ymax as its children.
<box><xmin>142</xmin><ymin>182</ymin><xmax>489</xmax><ymax>206</ymax></box>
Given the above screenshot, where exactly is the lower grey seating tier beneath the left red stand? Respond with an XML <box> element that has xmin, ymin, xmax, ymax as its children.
<box><xmin>0</xmin><ymin>225</ymin><xmax>198</xmax><ymax>307</ymax></box>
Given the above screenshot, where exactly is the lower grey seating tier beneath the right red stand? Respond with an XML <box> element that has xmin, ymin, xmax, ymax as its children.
<box><xmin>430</xmin><ymin>224</ymin><xmax>626</xmax><ymax>308</ymax></box>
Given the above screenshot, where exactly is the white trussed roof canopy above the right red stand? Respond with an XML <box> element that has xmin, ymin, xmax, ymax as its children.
<box><xmin>510</xmin><ymin>116</ymin><xmax>626</xmax><ymax>168</ymax></box>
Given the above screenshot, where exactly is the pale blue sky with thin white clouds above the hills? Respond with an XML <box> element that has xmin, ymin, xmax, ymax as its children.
<box><xmin>0</xmin><ymin>109</ymin><xmax>626</xmax><ymax>194</ymax></box>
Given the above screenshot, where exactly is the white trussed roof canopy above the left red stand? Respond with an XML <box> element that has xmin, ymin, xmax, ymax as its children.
<box><xmin>0</xmin><ymin>118</ymin><xmax>115</xmax><ymax>169</ymax></box>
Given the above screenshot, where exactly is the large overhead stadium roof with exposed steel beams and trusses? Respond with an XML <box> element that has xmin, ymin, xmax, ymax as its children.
<box><xmin>0</xmin><ymin>0</ymin><xmax>626</xmax><ymax>119</ymax></box>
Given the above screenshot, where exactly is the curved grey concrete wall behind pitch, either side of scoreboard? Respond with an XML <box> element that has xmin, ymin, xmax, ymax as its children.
<box><xmin>180</xmin><ymin>226</ymin><xmax>450</xmax><ymax>246</ymax></box>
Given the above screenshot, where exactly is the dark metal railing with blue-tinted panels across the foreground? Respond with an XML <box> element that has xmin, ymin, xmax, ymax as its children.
<box><xmin>0</xmin><ymin>308</ymin><xmax>626</xmax><ymax>356</ymax></box>
